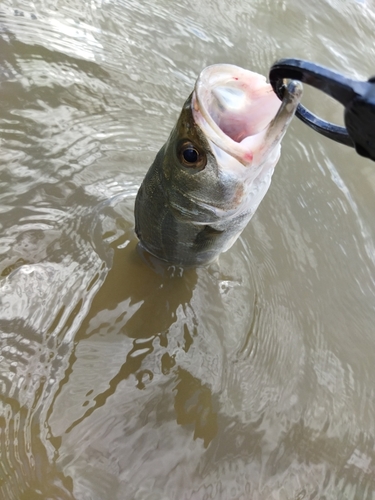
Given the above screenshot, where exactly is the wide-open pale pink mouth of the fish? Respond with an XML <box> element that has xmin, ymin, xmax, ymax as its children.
<box><xmin>192</xmin><ymin>64</ymin><xmax>301</xmax><ymax>165</ymax></box>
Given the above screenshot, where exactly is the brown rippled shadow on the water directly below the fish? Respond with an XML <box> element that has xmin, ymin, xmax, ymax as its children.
<box><xmin>64</xmin><ymin>234</ymin><xmax>222</xmax><ymax>447</ymax></box>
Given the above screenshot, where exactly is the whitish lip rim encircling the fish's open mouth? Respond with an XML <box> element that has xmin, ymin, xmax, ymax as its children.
<box><xmin>191</xmin><ymin>64</ymin><xmax>281</xmax><ymax>166</ymax></box>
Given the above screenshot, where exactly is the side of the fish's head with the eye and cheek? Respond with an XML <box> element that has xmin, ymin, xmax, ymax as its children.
<box><xmin>163</xmin><ymin>94</ymin><xmax>248</xmax><ymax>224</ymax></box>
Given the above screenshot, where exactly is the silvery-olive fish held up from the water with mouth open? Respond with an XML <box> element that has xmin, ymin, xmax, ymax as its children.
<box><xmin>134</xmin><ymin>64</ymin><xmax>302</xmax><ymax>268</ymax></box>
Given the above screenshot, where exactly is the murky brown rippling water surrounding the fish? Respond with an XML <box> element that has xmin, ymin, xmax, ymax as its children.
<box><xmin>0</xmin><ymin>0</ymin><xmax>375</xmax><ymax>500</ymax></box>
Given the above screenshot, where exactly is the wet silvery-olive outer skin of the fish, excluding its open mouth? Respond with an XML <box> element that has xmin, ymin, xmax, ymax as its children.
<box><xmin>135</xmin><ymin>65</ymin><xmax>301</xmax><ymax>267</ymax></box>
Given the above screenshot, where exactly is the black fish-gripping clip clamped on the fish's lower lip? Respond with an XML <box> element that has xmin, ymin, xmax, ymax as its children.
<box><xmin>269</xmin><ymin>59</ymin><xmax>375</xmax><ymax>161</ymax></box>
